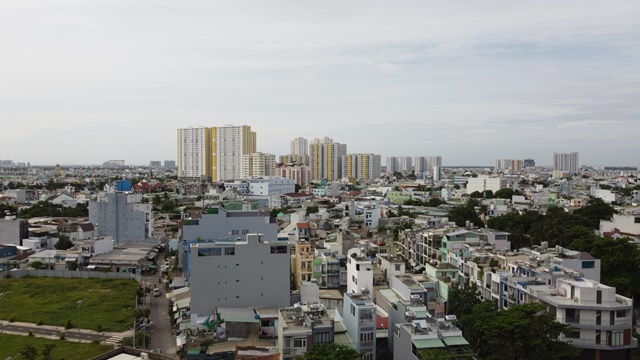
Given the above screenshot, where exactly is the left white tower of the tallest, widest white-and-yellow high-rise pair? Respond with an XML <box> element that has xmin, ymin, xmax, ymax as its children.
<box><xmin>178</xmin><ymin>127</ymin><xmax>211</xmax><ymax>179</ymax></box>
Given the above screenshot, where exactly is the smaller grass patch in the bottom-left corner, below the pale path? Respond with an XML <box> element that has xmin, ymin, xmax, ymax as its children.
<box><xmin>0</xmin><ymin>334</ymin><xmax>113</xmax><ymax>360</ymax></box>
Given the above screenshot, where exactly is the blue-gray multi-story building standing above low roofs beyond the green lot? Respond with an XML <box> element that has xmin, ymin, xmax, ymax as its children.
<box><xmin>89</xmin><ymin>191</ymin><xmax>153</xmax><ymax>243</ymax></box>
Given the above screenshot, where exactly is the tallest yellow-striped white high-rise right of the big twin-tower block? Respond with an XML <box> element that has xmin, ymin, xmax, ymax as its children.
<box><xmin>309</xmin><ymin>137</ymin><xmax>347</xmax><ymax>181</ymax></box>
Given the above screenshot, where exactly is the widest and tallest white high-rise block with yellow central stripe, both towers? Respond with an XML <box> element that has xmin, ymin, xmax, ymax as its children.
<box><xmin>178</xmin><ymin>125</ymin><xmax>257</xmax><ymax>181</ymax></box>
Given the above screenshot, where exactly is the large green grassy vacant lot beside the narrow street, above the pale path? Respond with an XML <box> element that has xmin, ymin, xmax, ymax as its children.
<box><xmin>0</xmin><ymin>277</ymin><xmax>138</xmax><ymax>332</ymax></box>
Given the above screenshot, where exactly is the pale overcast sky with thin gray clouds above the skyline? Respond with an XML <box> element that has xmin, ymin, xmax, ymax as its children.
<box><xmin>0</xmin><ymin>0</ymin><xmax>640</xmax><ymax>166</ymax></box>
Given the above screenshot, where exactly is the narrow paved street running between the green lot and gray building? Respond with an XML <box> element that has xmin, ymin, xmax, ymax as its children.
<box><xmin>149</xmin><ymin>260</ymin><xmax>177</xmax><ymax>355</ymax></box>
